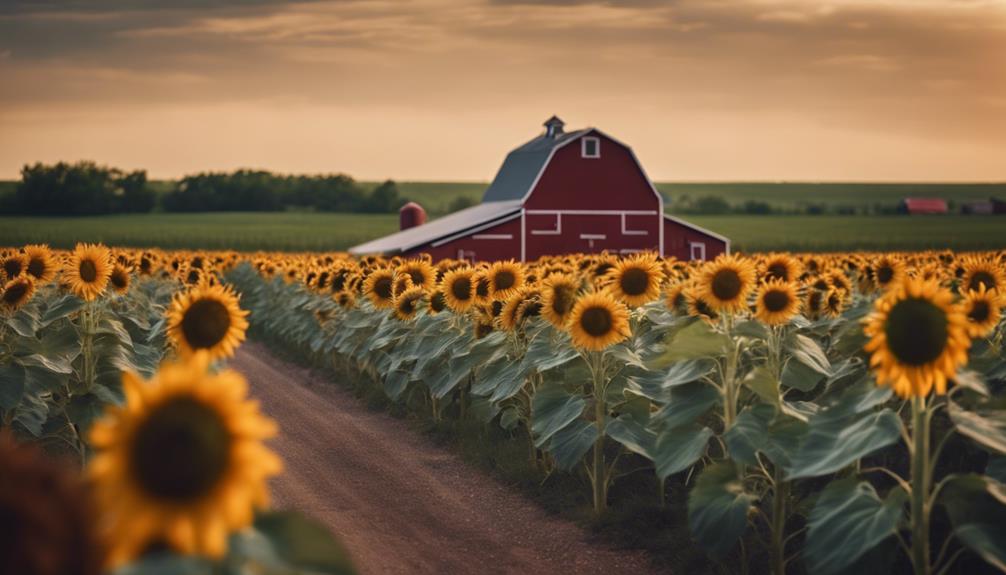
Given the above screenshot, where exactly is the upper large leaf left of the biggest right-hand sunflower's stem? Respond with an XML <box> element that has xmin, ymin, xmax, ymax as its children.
<box><xmin>788</xmin><ymin>409</ymin><xmax>900</xmax><ymax>480</ymax></box>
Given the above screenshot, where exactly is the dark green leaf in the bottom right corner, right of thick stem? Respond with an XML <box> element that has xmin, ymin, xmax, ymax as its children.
<box><xmin>940</xmin><ymin>474</ymin><xmax>1006</xmax><ymax>571</ymax></box>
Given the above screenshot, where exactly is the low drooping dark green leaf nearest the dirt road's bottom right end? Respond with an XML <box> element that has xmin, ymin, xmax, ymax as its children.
<box><xmin>688</xmin><ymin>461</ymin><xmax>756</xmax><ymax>557</ymax></box>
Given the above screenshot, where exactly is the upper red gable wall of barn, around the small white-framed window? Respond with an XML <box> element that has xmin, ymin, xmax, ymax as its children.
<box><xmin>525</xmin><ymin>133</ymin><xmax>659</xmax><ymax>210</ymax></box>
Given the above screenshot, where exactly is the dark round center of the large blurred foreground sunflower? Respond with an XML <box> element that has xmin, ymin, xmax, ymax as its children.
<box><xmin>129</xmin><ymin>397</ymin><xmax>231</xmax><ymax>503</ymax></box>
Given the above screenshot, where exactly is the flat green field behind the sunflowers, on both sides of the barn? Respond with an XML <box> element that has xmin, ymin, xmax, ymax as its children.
<box><xmin>0</xmin><ymin>212</ymin><xmax>1006</xmax><ymax>251</ymax></box>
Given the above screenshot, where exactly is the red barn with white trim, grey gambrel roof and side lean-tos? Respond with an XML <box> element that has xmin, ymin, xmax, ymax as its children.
<box><xmin>349</xmin><ymin>116</ymin><xmax>730</xmax><ymax>261</ymax></box>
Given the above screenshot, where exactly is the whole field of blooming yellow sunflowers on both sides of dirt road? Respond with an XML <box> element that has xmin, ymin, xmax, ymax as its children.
<box><xmin>0</xmin><ymin>245</ymin><xmax>1006</xmax><ymax>574</ymax></box>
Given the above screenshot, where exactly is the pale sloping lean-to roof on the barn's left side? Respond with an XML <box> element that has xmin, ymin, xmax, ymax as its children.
<box><xmin>349</xmin><ymin>199</ymin><xmax>521</xmax><ymax>254</ymax></box>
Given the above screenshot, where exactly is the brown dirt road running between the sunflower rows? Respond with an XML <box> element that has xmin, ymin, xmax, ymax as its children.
<box><xmin>231</xmin><ymin>343</ymin><xmax>654</xmax><ymax>575</ymax></box>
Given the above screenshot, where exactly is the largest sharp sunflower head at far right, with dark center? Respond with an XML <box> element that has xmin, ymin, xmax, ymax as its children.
<box><xmin>863</xmin><ymin>279</ymin><xmax>971</xmax><ymax>398</ymax></box>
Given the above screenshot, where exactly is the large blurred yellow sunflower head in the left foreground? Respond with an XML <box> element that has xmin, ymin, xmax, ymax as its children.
<box><xmin>89</xmin><ymin>352</ymin><xmax>282</xmax><ymax>565</ymax></box>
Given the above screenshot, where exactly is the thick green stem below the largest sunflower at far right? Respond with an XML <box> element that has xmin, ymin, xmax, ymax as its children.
<box><xmin>911</xmin><ymin>395</ymin><xmax>932</xmax><ymax>575</ymax></box>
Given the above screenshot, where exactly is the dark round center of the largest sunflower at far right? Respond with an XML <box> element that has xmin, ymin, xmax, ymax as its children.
<box><xmin>884</xmin><ymin>298</ymin><xmax>948</xmax><ymax>366</ymax></box>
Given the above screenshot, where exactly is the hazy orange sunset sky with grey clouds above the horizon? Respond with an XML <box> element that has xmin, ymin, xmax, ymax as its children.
<box><xmin>0</xmin><ymin>0</ymin><xmax>1006</xmax><ymax>181</ymax></box>
